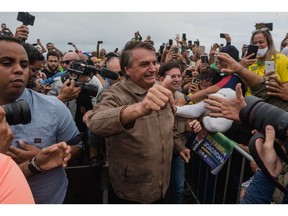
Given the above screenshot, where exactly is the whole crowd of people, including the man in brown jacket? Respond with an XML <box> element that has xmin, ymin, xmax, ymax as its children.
<box><xmin>0</xmin><ymin>23</ymin><xmax>288</xmax><ymax>204</ymax></box>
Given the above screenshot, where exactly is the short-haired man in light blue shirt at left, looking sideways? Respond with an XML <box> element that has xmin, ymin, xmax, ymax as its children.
<box><xmin>0</xmin><ymin>36</ymin><xmax>82</xmax><ymax>204</ymax></box>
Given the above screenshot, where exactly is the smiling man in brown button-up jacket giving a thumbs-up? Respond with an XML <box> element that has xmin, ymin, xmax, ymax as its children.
<box><xmin>87</xmin><ymin>41</ymin><xmax>190</xmax><ymax>203</ymax></box>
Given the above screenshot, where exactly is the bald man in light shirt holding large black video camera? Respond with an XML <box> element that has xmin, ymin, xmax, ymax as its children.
<box><xmin>48</xmin><ymin>56</ymin><xmax>103</xmax><ymax>165</ymax></box>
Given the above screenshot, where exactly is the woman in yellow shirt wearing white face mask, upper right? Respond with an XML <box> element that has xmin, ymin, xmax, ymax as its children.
<box><xmin>246</xmin><ymin>28</ymin><xmax>288</xmax><ymax>96</ymax></box>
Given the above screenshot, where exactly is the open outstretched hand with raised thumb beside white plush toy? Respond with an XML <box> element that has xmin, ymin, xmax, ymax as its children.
<box><xmin>204</xmin><ymin>83</ymin><xmax>246</xmax><ymax>121</ymax></box>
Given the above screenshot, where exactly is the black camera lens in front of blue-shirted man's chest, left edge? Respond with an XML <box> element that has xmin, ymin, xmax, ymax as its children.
<box><xmin>2</xmin><ymin>100</ymin><xmax>31</xmax><ymax>125</ymax></box>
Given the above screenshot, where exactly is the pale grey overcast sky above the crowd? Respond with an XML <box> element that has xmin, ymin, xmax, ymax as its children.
<box><xmin>0</xmin><ymin>11</ymin><xmax>288</xmax><ymax>56</ymax></box>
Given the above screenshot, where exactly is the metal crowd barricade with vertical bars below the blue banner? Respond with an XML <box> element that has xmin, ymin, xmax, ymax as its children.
<box><xmin>185</xmin><ymin>134</ymin><xmax>253</xmax><ymax>204</ymax></box>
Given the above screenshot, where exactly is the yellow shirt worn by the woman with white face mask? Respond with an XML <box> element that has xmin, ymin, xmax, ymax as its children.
<box><xmin>246</xmin><ymin>53</ymin><xmax>288</xmax><ymax>96</ymax></box>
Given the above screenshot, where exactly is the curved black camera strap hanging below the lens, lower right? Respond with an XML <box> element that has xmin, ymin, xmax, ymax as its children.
<box><xmin>249</xmin><ymin>133</ymin><xmax>288</xmax><ymax>194</ymax></box>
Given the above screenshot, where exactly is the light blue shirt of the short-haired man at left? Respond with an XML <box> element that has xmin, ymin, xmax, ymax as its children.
<box><xmin>10</xmin><ymin>89</ymin><xmax>82</xmax><ymax>204</ymax></box>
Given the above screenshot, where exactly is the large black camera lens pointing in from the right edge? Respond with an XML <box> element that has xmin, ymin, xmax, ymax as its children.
<box><xmin>239</xmin><ymin>96</ymin><xmax>288</xmax><ymax>143</ymax></box>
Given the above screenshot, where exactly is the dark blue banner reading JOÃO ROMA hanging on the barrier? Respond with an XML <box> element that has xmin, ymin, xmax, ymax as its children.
<box><xmin>191</xmin><ymin>130</ymin><xmax>235</xmax><ymax>175</ymax></box>
